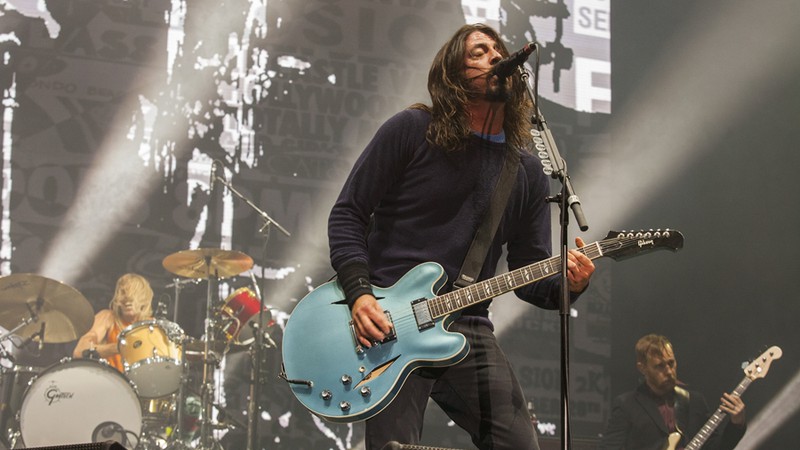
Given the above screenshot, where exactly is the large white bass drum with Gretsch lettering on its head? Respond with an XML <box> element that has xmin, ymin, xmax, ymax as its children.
<box><xmin>19</xmin><ymin>359</ymin><xmax>142</xmax><ymax>448</ymax></box>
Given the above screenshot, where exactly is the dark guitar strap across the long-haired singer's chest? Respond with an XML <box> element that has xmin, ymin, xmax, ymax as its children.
<box><xmin>453</xmin><ymin>151</ymin><xmax>519</xmax><ymax>288</ymax></box>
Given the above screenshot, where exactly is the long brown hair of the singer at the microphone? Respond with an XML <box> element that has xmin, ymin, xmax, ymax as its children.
<box><xmin>411</xmin><ymin>23</ymin><xmax>532</xmax><ymax>151</ymax></box>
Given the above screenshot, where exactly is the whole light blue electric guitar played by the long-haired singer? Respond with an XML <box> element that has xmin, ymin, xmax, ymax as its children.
<box><xmin>281</xmin><ymin>229</ymin><xmax>683</xmax><ymax>422</ymax></box>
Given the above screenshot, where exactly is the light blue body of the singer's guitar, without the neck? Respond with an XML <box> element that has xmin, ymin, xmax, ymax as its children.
<box><xmin>283</xmin><ymin>262</ymin><xmax>469</xmax><ymax>422</ymax></box>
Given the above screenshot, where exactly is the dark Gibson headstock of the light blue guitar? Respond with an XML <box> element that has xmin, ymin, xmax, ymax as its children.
<box><xmin>601</xmin><ymin>228</ymin><xmax>683</xmax><ymax>261</ymax></box>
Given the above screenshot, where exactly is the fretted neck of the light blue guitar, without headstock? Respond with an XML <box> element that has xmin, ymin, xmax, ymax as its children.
<box><xmin>428</xmin><ymin>239</ymin><xmax>604</xmax><ymax>319</ymax></box>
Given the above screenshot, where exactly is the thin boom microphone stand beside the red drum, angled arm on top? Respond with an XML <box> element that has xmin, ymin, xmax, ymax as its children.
<box><xmin>211</xmin><ymin>171</ymin><xmax>292</xmax><ymax>450</ymax></box>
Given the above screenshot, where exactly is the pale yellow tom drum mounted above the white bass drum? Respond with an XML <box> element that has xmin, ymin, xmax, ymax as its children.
<box><xmin>118</xmin><ymin>319</ymin><xmax>183</xmax><ymax>398</ymax></box>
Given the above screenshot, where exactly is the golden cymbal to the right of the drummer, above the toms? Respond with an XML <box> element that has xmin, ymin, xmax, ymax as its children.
<box><xmin>163</xmin><ymin>248</ymin><xmax>253</xmax><ymax>278</ymax></box>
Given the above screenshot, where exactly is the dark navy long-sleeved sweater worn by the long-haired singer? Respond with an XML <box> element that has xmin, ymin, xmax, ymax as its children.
<box><xmin>328</xmin><ymin>109</ymin><xmax>576</xmax><ymax>317</ymax></box>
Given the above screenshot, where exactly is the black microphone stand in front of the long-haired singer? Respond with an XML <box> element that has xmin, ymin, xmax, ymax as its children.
<box><xmin>518</xmin><ymin>44</ymin><xmax>589</xmax><ymax>450</ymax></box>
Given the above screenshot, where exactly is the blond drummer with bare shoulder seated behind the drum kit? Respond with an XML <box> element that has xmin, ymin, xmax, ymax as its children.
<box><xmin>72</xmin><ymin>273</ymin><xmax>153</xmax><ymax>372</ymax></box>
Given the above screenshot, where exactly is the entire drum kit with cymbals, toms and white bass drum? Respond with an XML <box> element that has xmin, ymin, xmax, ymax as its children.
<box><xmin>0</xmin><ymin>248</ymin><xmax>270</xmax><ymax>450</ymax></box>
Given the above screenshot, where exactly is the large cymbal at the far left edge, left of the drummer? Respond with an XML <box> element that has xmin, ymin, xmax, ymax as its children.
<box><xmin>0</xmin><ymin>273</ymin><xmax>94</xmax><ymax>344</ymax></box>
